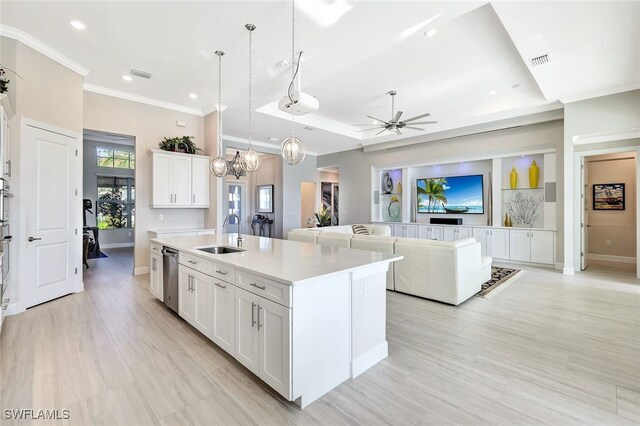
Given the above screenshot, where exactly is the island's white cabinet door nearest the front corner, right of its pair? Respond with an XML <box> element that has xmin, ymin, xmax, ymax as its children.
<box><xmin>257</xmin><ymin>297</ymin><xmax>291</xmax><ymax>399</ymax></box>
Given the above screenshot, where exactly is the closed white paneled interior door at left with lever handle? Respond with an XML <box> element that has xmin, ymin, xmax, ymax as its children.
<box><xmin>20</xmin><ymin>124</ymin><xmax>81</xmax><ymax>308</ymax></box>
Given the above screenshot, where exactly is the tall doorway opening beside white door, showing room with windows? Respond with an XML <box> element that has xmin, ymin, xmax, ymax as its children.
<box><xmin>82</xmin><ymin>129</ymin><xmax>136</xmax><ymax>275</ymax></box>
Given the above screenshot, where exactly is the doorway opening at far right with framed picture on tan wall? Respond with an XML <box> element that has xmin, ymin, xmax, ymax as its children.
<box><xmin>580</xmin><ymin>151</ymin><xmax>638</xmax><ymax>275</ymax></box>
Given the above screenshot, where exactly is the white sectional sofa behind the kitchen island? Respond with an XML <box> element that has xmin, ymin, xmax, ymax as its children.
<box><xmin>288</xmin><ymin>225</ymin><xmax>492</xmax><ymax>305</ymax></box>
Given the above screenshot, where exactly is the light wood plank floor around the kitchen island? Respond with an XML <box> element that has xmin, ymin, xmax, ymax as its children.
<box><xmin>0</xmin><ymin>251</ymin><xmax>640</xmax><ymax>425</ymax></box>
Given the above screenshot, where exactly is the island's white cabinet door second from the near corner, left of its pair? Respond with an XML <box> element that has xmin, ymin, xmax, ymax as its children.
<box><xmin>235</xmin><ymin>287</ymin><xmax>260</xmax><ymax>375</ymax></box>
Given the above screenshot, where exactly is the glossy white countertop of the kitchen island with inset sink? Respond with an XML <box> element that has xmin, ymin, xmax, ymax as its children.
<box><xmin>151</xmin><ymin>234</ymin><xmax>402</xmax><ymax>285</ymax></box>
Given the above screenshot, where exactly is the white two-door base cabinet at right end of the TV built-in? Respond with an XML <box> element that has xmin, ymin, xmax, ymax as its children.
<box><xmin>509</xmin><ymin>229</ymin><xmax>555</xmax><ymax>264</ymax></box>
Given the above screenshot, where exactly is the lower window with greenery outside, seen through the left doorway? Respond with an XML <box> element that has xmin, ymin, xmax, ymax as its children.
<box><xmin>97</xmin><ymin>176</ymin><xmax>136</xmax><ymax>229</ymax></box>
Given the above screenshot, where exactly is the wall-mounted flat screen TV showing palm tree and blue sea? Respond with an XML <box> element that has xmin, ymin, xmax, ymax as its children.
<box><xmin>416</xmin><ymin>175</ymin><xmax>484</xmax><ymax>214</ymax></box>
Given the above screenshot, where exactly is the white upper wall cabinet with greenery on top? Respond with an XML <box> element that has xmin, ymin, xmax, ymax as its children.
<box><xmin>151</xmin><ymin>150</ymin><xmax>210</xmax><ymax>208</ymax></box>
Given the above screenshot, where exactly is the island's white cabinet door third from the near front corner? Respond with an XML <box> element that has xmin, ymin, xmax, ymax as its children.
<box><xmin>211</xmin><ymin>280</ymin><xmax>236</xmax><ymax>355</ymax></box>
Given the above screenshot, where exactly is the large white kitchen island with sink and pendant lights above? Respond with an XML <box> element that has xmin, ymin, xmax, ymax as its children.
<box><xmin>151</xmin><ymin>234</ymin><xmax>402</xmax><ymax>408</ymax></box>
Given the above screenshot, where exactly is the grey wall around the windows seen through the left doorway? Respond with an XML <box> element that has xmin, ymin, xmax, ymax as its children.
<box><xmin>82</xmin><ymin>139</ymin><xmax>135</xmax><ymax>248</ymax></box>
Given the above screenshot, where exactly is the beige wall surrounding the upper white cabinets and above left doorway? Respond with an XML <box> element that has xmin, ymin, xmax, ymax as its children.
<box><xmin>84</xmin><ymin>92</ymin><xmax>202</xmax><ymax>273</ymax></box>
